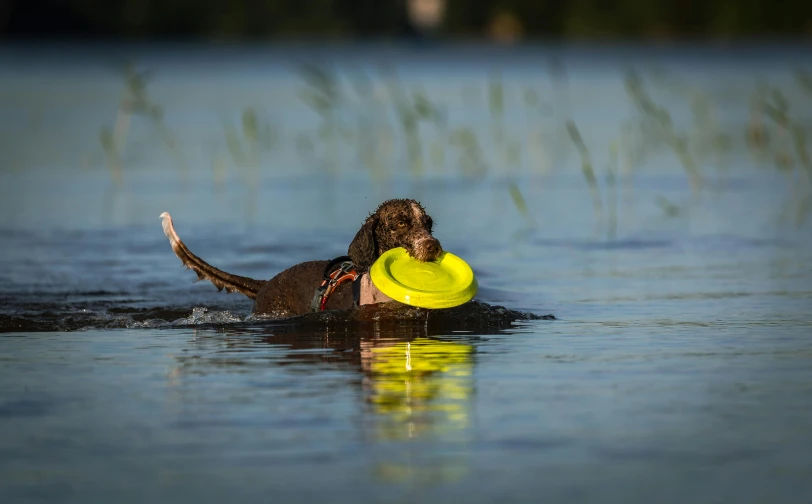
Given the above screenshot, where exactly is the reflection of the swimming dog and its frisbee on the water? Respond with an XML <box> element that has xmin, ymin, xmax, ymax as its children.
<box><xmin>169</xmin><ymin>326</ymin><xmax>474</xmax><ymax>485</ymax></box>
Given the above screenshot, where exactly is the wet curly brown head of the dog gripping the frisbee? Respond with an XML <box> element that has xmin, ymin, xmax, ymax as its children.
<box><xmin>348</xmin><ymin>199</ymin><xmax>443</xmax><ymax>270</ymax></box>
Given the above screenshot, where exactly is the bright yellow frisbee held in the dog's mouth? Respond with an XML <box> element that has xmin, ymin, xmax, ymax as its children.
<box><xmin>369</xmin><ymin>247</ymin><xmax>477</xmax><ymax>308</ymax></box>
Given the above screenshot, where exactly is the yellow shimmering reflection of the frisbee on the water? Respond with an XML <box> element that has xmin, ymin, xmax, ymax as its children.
<box><xmin>362</xmin><ymin>337</ymin><xmax>474</xmax><ymax>484</ymax></box>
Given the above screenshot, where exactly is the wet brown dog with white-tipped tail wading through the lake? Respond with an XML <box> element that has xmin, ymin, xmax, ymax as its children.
<box><xmin>161</xmin><ymin>199</ymin><xmax>443</xmax><ymax>318</ymax></box>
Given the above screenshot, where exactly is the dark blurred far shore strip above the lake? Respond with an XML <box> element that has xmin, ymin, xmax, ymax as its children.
<box><xmin>0</xmin><ymin>0</ymin><xmax>812</xmax><ymax>42</ymax></box>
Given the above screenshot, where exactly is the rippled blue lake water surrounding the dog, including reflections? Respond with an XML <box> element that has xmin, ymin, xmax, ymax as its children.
<box><xmin>0</xmin><ymin>46</ymin><xmax>812</xmax><ymax>503</ymax></box>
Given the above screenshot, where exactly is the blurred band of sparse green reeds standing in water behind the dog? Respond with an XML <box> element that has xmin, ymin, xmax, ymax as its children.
<box><xmin>99</xmin><ymin>59</ymin><xmax>812</xmax><ymax>232</ymax></box>
